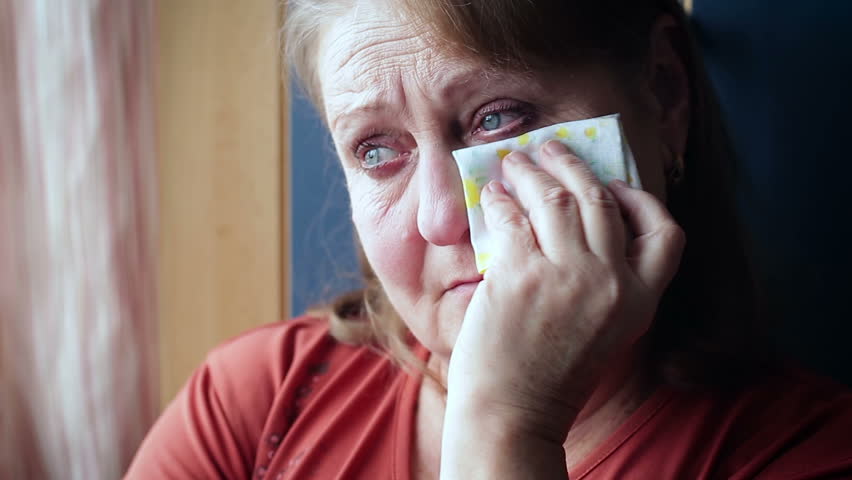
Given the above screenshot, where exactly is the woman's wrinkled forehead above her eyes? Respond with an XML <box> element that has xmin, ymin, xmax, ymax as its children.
<box><xmin>317</xmin><ymin>5</ymin><xmax>544</xmax><ymax>131</ymax></box>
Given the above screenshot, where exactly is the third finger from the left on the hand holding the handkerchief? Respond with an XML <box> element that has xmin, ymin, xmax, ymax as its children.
<box><xmin>541</xmin><ymin>140</ymin><xmax>626</xmax><ymax>261</ymax></box>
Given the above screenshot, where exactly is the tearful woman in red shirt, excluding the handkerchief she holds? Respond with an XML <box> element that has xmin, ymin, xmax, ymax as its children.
<box><xmin>128</xmin><ymin>0</ymin><xmax>852</xmax><ymax>479</ymax></box>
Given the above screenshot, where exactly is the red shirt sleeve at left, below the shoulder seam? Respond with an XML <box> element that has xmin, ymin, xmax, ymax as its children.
<box><xmin>125</xmin><ymin>320</ymin><xmax>316</xmax><ymax>480</ymax></box>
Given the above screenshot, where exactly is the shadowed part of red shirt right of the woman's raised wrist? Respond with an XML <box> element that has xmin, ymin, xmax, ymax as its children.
<box><xmin>572</xmin><ymin>369</ymin><xmax>852</xmax><ymax>480</ymax></box>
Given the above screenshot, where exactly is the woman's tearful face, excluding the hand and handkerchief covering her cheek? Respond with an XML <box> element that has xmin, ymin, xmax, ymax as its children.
<box><xmin>318</xmin><ymin>2</ymin><xmax>664</xmax><ymax>357</ymax></box>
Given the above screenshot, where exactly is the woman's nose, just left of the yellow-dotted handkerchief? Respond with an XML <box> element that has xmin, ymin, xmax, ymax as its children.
<box><xmin>417</xmin><ymin>149</ymin><xmax>468</xmax><ymax>246</ymax></box>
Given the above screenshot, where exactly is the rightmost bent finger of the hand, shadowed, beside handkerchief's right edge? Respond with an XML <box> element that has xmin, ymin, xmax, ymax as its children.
<box><xmin>610</xmin><ymin>180</ymin><xmax>686</xmax><ymax>293</ymax></box>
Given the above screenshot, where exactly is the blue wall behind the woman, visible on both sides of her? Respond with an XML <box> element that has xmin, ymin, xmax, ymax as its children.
<box><xmin>291</xmin><ymin>0</ymin><xmax>852</xmax><ymax>385</ymax></box>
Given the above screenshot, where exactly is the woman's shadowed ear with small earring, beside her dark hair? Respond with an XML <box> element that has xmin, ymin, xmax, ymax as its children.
<box><xmin>646</xmin><ymin>15</ymin><xmax>691</xmax><ymax>170</ymax></box>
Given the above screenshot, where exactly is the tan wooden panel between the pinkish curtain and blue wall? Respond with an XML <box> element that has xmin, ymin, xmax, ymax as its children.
<box><xmin>157</xmin><ymin>0</ymin><xmax>289</xmax><ymax>403</ymax></box>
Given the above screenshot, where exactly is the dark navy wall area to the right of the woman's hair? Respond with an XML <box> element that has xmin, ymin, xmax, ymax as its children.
<box><xmin>694</xmin><ymin>0</ymin><xmax>852</xmax><ymax>385</ymax></box>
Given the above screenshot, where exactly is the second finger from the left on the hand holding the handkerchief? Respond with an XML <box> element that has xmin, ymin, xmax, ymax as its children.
<box><xmin>503</xmin><ymin>152</ymin><xmax>588</xmax><ymax>259</ymax></box>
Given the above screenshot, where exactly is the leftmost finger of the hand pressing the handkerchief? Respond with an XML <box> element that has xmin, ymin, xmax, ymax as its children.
<box><xmin>480</xmin><ymin>181</ymin><xmax>541</xmax><ymax>265</ymax></box>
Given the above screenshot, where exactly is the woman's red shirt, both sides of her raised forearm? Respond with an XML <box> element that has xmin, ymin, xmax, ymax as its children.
<box><xmin>126</xmin><ymin>317</ymin><xmax>852</xmax><ymax>480</ymax></box>
